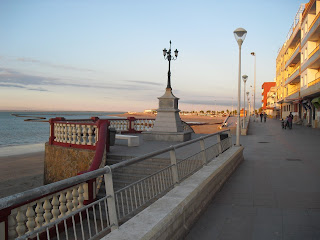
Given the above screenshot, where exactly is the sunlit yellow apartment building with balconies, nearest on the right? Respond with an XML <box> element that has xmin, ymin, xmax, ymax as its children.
<box><xmin>276</xmin><ymin>0</ymin><xmax>320</xmax><ymax>127</ymax></box>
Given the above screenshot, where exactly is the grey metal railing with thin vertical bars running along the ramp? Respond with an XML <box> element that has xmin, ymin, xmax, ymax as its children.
<box><xmin>0</xmin><ymin>130</ymin><xmax>232</xmax><ymax>239</ymax></box>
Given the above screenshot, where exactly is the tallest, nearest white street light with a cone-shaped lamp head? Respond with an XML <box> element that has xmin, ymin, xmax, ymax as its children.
<box><xmin>233</xmin><ymin>28</ymin><xmax>247</xmax><ymax>146</ymax></box>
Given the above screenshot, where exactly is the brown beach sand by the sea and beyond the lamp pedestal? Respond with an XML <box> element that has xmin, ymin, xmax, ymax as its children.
<box><xmin>0</xmin><ymin>113</ymin><xmax>234</xmax><ymax>198</ymax></box>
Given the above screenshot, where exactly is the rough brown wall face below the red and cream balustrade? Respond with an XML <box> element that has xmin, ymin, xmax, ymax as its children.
<box><xmin>44</xmin><ymin>143</ymin><xmax>95</xmax><ymax>184</ymax></box>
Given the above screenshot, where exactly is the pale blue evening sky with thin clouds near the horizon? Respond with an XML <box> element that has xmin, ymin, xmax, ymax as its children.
<box><xmin>0</xmin><ymin>0</ymin><xmax>307</xmax><ymax>111</ymax></box>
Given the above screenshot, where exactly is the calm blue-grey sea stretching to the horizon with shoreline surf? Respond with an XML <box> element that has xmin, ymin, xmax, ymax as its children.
<box><xmin>0</xmin><ymin>111</ymin><xmax>123</xmax><ymax>157</ymax></box>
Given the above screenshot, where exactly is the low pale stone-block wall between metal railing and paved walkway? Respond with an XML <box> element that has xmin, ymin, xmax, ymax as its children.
<box><xmin>102</xmin><ymin>146</ymin><xmax>244</xmax><ymax>240</ymax></box>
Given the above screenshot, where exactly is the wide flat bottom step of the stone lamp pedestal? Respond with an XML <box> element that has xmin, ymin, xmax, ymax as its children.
<box><xmin>142</xmin><ymin>131</ymin><xmax>192</xmax><ymax>142</ymax></box>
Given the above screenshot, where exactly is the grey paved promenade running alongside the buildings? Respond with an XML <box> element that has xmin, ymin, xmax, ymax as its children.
<box><xmin>186</xmin><ymin>119</ymin><xmax>320</xmax><ymax>240</ymax></box>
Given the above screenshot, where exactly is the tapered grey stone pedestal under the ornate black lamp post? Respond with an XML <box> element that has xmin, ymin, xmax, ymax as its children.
<box><xmin>142</xmin><ymin>88</ymin><xmax>191</xmax><ymax>142</ymax></box>
